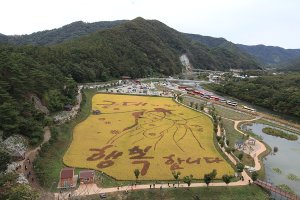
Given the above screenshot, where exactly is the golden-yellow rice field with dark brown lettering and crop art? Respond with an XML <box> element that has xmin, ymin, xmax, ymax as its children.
<box><xmin>64</xmin><ymin>94</ymin><xmax>234</xmax><ymax>180</ymax></box>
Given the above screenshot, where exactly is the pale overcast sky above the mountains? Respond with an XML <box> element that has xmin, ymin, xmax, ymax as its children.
<box><xmin>0</xmin><ymin>0</ymin><xmax>300</xmax><ymax>48</ymax></box>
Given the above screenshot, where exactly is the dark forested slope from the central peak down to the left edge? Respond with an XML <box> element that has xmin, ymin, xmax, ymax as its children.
<box><xmin>0</xmin><ymin>18</ymin><xmax>257</xmax><ymax>142</ymax></box>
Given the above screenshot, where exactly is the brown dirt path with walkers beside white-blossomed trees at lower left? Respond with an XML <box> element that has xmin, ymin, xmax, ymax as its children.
<box><xmin>17</xmin><ymin>127</ymin><xmax>51</xmax><ymax>189</ymax></box>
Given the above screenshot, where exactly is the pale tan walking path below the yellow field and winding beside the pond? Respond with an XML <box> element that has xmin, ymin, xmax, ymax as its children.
<box><xmin>54</xmin><ymin>98</ymin><xmax>266</xmax><ymax>199</ymax></box>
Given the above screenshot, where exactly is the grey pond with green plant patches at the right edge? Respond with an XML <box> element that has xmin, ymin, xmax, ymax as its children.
<box><xmin>242</xmin><ymin>123</ymin><xmax>300</xmax><ymax>195</ymax></box>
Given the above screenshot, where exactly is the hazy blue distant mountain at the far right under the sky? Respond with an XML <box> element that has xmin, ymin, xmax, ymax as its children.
<box><xmin>238</xmin><ymin>44</ymin><xmax>300</xmax><ymax>65</ymax></box>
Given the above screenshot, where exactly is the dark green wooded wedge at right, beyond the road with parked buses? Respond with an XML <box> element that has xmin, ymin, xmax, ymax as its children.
<box><xmin>208</xmin><ymin>72</ymin><xmax>300</xmax><ymax>117</ymax></box>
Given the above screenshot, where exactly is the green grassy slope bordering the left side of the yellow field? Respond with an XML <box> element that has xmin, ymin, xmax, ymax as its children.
<box><xmin>34</xmin><ymin>90</ymin><xmax>96</xmax><ymax>191</ymax></box>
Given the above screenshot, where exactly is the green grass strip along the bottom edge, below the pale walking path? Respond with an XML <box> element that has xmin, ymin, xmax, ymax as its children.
<box><xmin>74</xmin><ymin>185</ymin><xmax>269</xmax><ymax>200</ymax></box>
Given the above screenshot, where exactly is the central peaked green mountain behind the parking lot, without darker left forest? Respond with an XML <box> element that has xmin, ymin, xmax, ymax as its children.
<box><xmin>55</xmin><ymin>18</ymin><xmax>257</xmax><ymax>77</ymax></box>
